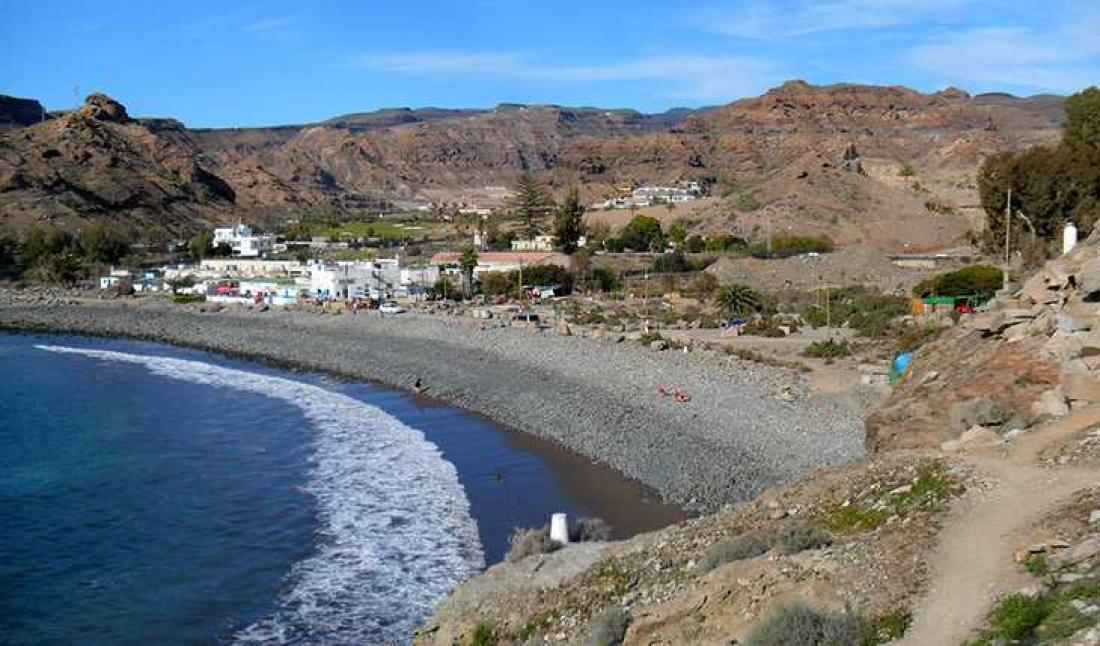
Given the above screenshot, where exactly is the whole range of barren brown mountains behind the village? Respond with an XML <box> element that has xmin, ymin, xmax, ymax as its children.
<box><xmin>0</xmin><ymin>81</ymin><xmax>1062</xmax><ymax>249</ymax></box>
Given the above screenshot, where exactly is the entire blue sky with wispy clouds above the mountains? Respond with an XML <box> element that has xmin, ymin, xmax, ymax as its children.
<box><xmin>0</xmin><ymin>0</ymin><xmax>1100</xmax><ymax>125</ymax></box>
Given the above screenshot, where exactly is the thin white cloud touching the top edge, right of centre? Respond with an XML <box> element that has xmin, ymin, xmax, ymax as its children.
<box><xmin>695</xmin><ymin>0</ymin><xmax>976</xmax><ymax>41</ymax></box>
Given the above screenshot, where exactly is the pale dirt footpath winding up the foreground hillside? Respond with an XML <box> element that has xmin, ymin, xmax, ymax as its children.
<box><xmin>897</xmin><ymin>407</ymin><xmax>1100</xmax><ymax>646</ymax></box>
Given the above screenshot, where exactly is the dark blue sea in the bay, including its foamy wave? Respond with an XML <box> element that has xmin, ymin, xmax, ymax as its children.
<box><xmin>0</xmin><ymin>335</ymin><xmax>679</xmax><ymax>645</ymax></box>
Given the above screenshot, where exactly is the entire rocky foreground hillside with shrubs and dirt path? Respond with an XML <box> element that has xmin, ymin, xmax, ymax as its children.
<box><xmin>415</xmin><ymin>232</ymin><xmax>1100</xmax><ymax>645</ymax></box>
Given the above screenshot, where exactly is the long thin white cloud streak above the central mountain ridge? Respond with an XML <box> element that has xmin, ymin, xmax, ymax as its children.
<box><xmin>354</xmin><ymin>52</ymin><xmax>780</xmax><ymax>100</ymax></box>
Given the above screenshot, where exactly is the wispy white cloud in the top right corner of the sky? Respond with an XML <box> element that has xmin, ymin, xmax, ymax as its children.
<box><xmin>909</xmin><ymin>9</ymin><xmax>1100</xmax><ymax>92</ymax></box>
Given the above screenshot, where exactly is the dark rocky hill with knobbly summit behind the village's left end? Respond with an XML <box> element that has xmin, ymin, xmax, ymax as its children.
<box><xmin>0</xmin><ymin>95</ymin><xmax>235</xmax><ymax>233</ymax></box>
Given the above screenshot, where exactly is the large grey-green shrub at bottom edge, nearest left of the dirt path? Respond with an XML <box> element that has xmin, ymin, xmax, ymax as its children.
<box><xmin>745</xmin><ymin>603</ymin><xmax>861</xmax><ymax>646</ymax></box>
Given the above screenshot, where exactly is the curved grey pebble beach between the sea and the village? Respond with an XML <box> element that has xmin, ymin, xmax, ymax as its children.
<box><xmin>0</xmin><ymin>293</ymin><xmax>865</xmax><ymax>513</ymax></box>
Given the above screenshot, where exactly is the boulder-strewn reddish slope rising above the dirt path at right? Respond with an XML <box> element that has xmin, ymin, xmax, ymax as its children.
<box><xmin>867</xmin><ymin>233</ymin><xmax>1100</xmax><ymax>451</ymax></box>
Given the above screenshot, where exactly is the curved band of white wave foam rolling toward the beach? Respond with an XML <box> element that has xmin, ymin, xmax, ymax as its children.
<box><xmin>36</xmin><ymin>344</ymin><xmax>485</xmax><ymax>644</ymax></box>
